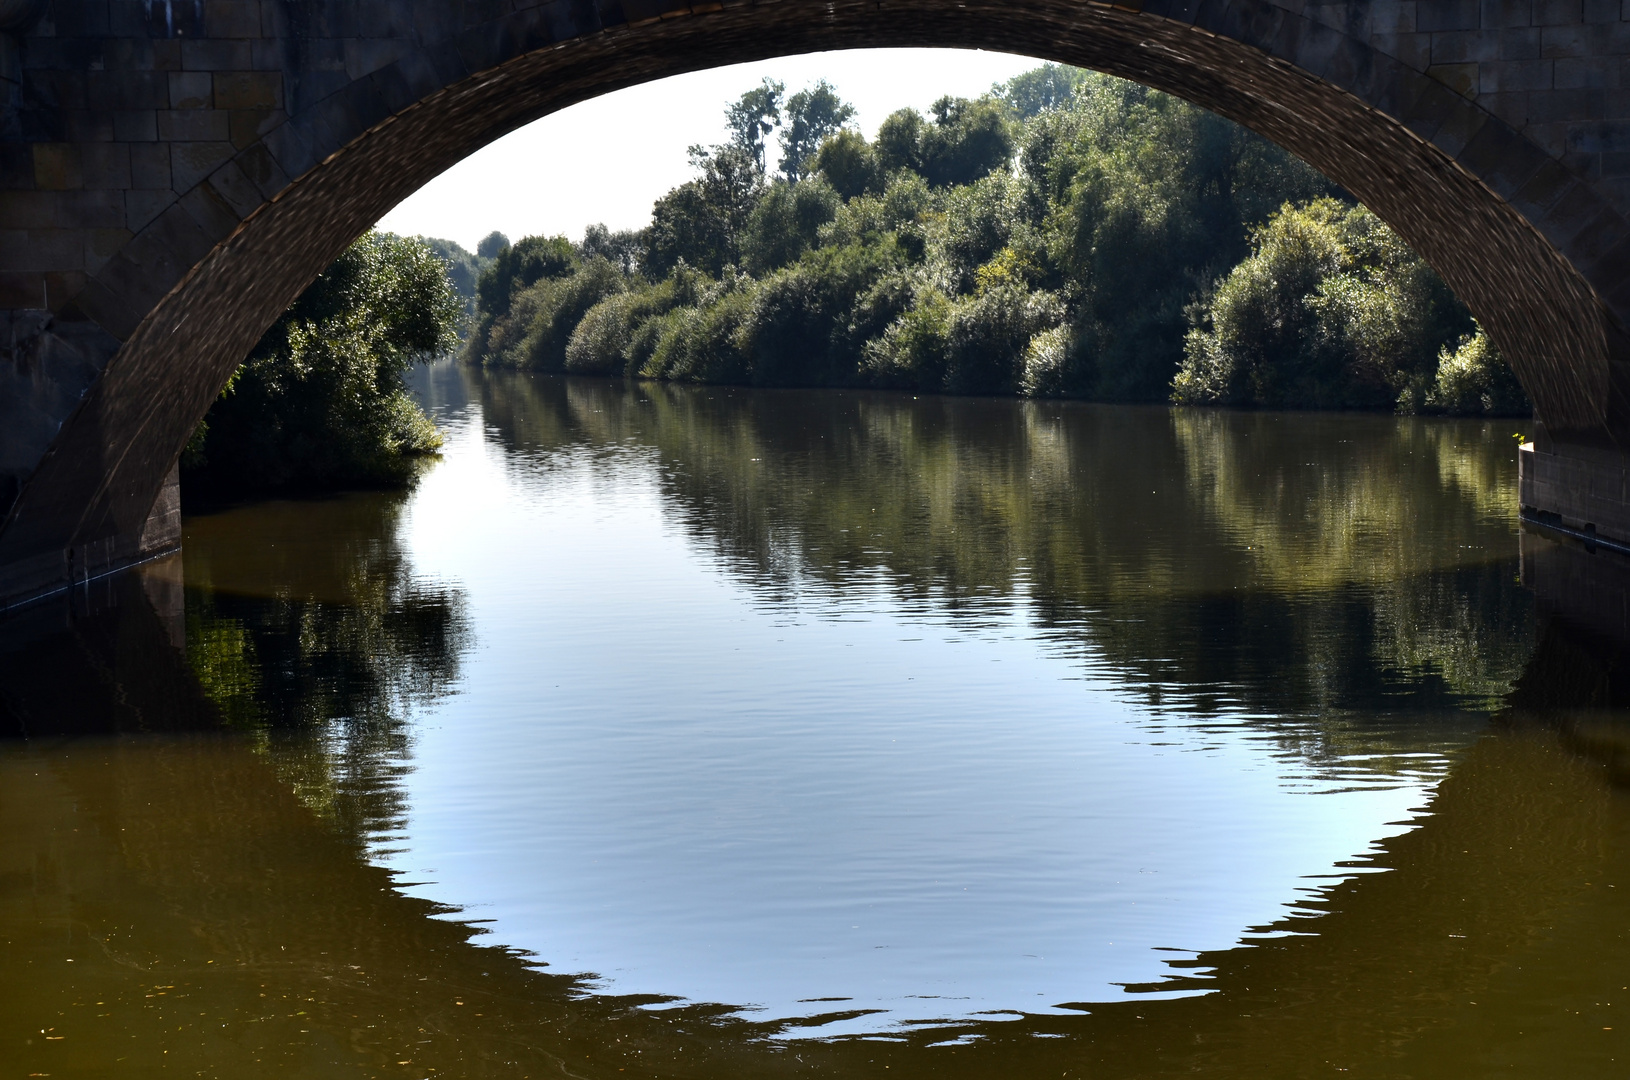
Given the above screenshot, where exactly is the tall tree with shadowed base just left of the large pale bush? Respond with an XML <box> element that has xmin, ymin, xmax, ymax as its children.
<box><xmin>1020</xmin><ymin>75</ymin><xmax>1330</xmax><ymax>401</ymax></box>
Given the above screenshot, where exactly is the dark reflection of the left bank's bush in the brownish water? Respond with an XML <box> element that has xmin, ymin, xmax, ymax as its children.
<box><xmin>186</xmin><ymin>494</ymin><xmax>469</xmax><ymax>837</ymax></box>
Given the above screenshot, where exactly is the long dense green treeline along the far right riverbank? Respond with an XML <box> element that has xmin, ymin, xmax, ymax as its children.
<box><xmin>443</xmin><ymin>65</ymin><xmax>1529</xmax><ymax>414</ymax></box>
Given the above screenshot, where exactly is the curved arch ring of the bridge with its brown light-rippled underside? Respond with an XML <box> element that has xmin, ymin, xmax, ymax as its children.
<box><xmin>0</xmin><ymin>0</ymin><xmax>1630</xmax><ymax>603</ymax></box>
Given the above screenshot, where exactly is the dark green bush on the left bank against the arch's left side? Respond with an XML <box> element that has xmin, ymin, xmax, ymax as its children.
<box><xmin>183</xmin><ymin>233</ymin><xmax>461</xmax><ymax>494</ymax></box>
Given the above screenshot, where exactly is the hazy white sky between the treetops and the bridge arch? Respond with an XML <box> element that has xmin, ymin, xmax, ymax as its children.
<box><xmin>380</xmin><ymin>49</ymin><xmax>1040</xmax><ymax>249</ymax></box>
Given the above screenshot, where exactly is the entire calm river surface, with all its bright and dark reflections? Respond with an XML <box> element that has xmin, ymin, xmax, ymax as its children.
<box><xmin>0</xmin><ymin>368</ymin><xmax>1630</xmax><ymax>1077</ymax></box>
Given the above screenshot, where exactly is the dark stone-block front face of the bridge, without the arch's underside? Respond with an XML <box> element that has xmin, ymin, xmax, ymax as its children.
<box><xmin>0</xmin><ymin>0</ymin><xmax>1630</xmax><ymax>604</ymax></box>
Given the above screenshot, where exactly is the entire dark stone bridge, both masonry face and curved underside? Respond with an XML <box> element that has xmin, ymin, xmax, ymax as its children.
<box><xmin>0</xmin><ymin>0</ymin><xmax>1630</xmax><ymax>608</ymax></box>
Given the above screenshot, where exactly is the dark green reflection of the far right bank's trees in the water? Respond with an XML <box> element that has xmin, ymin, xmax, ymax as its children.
<box><xmin>469</xmin><ymin>378</ymin><xmax>1532</xmax><ymax>759</ymax></box>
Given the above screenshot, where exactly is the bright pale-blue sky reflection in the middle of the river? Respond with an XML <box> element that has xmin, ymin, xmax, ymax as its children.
<box><xmin>378</xmin><ymin>369</ymin><xmax>1473</xmax><ymax>1034</ymax></box>
